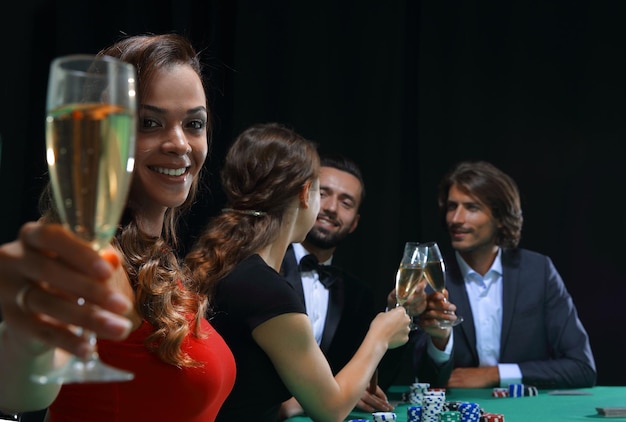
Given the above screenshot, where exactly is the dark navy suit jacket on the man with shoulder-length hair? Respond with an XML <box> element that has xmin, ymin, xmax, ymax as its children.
<box><xmin>414</xmin><ymin>249</ymin><xmax>596</xmax><ymax>388</ymax></box>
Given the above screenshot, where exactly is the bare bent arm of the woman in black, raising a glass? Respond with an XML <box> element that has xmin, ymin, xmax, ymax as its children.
<box><xmin>252</xmin><ymin>308</ymin><xmax>409</xmax><ymax>421</ymax></box>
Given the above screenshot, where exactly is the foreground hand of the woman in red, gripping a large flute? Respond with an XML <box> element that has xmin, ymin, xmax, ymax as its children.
<box><xmin>0</xmin><ymin>222</ymin><xmax>132</xmax><ymax>356</ymax></box>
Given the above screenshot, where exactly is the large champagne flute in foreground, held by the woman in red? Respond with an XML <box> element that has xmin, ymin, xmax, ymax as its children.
<box><xmin>33</xmin><ymin>55</ymin><xmax>137</xmax><ymax>384</ymax></box>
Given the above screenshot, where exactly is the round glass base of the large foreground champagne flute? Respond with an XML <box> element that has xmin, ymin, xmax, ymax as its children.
<box><xmin>31</xmin><ymin>358</ymin><xmax>135</xmax><ymax>384</ymax></box>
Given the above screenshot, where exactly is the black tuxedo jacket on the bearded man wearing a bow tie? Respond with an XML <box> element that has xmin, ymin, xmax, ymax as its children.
<box><xmin>281</xmin><ymin>245</ymin><xmax>376</xmax><ymax>373</ymax></box>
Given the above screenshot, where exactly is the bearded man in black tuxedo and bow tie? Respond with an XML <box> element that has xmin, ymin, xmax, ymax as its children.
<box><xmin>281</xmin><ymin>155</ymin><xmax>393</xmax><ymax>417</ymax></box>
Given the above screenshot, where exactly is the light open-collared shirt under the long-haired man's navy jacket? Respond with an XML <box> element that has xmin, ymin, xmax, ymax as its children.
<box><xmin>428</xmin><ymin>250</ymin><xmax>522</xmax><ymax>387</ymax></box>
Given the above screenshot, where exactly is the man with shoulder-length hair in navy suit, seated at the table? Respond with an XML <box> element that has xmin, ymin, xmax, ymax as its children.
<box><xmin>414</xmin><ymin>162</ymin><xmax>596</xmax><ymax>388</ymax></box>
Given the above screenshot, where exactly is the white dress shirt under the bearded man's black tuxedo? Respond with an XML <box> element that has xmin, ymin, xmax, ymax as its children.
<box><xmin>293</xmin><ymin>243</ymin><xmax>333</xmax><ymax>344</ymax></box>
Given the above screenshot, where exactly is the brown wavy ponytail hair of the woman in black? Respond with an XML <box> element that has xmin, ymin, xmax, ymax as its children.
<box><xmin>186</xmin><ymin>123</ymin><xmax>320</xmax><ymax>304</ymax></box>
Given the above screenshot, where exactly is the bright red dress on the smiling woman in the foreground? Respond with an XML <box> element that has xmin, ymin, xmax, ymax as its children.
<box><xmin>49</xmin><ymin>320</ymin><xmax>236</xmax><ymax>422</ymax></box>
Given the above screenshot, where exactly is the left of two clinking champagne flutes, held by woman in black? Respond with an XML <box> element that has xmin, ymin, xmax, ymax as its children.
<box><xmin>396</xmin><ymin>242</ymin><xmax>428</xmax><ymax>330</ymax></box>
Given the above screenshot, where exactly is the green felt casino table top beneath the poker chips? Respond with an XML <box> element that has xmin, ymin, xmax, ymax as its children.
<box><xmin>287</xmin><ymin>386</ymin><xmax>626</xmax><ymax>422</ymax></box>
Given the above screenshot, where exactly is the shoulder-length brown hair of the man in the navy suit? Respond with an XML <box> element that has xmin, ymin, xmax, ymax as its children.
<box><xmin>437</xmin><ymin>161</ymin><xmax>524</xmax><ymax>248</ymax></box>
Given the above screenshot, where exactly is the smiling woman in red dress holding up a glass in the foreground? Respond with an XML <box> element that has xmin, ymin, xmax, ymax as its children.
<box><xmin>0</xmin><ymin>34</ymin><xmax>235</xmax><ymax>422</ymax></box>
